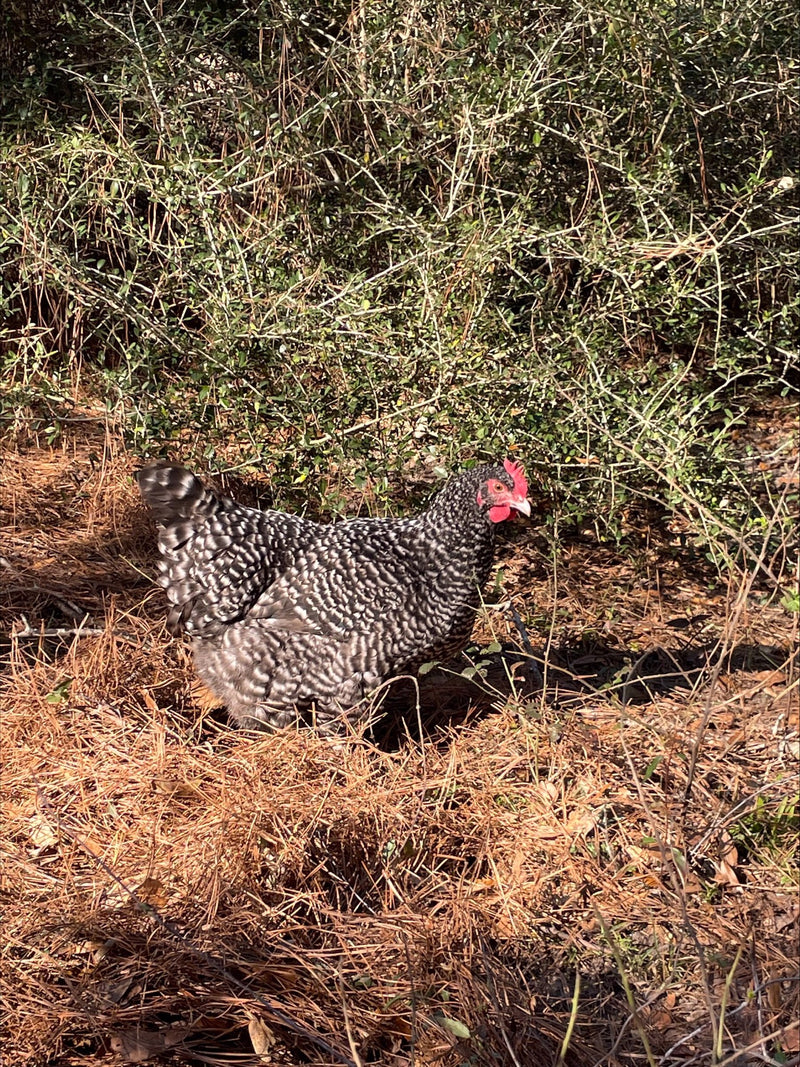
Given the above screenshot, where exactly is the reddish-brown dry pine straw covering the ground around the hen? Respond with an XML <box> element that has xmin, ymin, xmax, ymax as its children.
<box><xmin>0</xmin><ymin>434</ymin><xmax>798</xmax><ymax>1067</ymax></box>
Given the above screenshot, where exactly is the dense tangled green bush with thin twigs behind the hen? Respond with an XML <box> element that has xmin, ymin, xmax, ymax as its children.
<box><xmin>0</xmin><ymin>0</ymin><xmax>798</xmax><ymax>544</ymax></box>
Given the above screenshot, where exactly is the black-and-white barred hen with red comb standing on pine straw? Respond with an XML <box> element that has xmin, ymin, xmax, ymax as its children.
<box><xmin>139</xmin><ymin>460</ymin><xmax>530</xmax><ymax>729</ymax></box>
